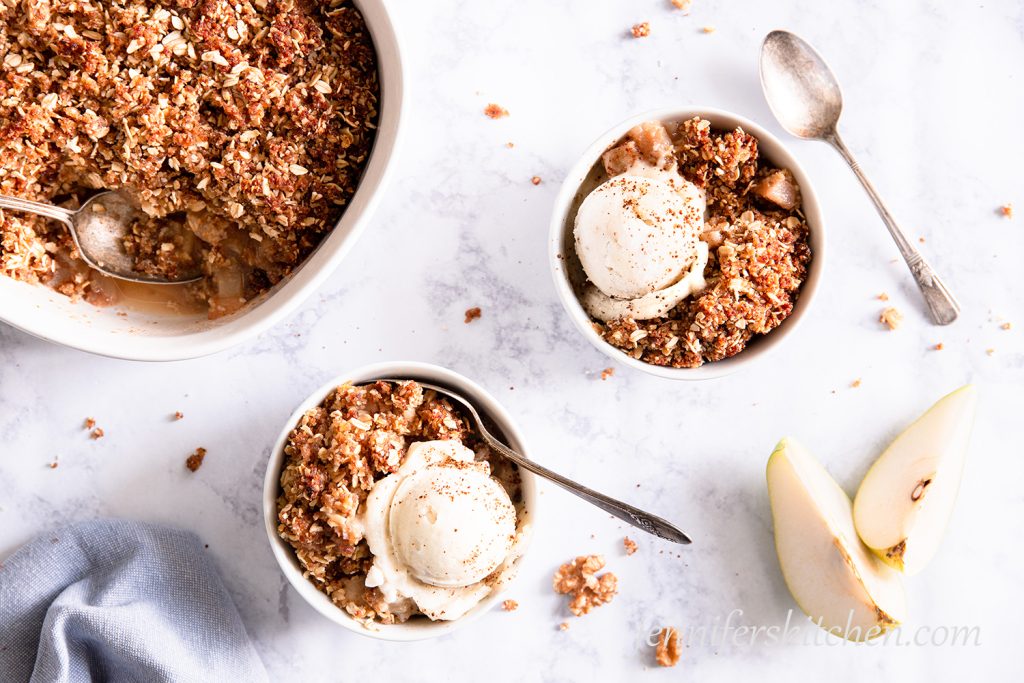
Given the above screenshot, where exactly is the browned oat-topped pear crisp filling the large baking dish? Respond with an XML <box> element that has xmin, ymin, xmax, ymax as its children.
<box><xmin>0</xmin><ymin>0</ymin><xmax>379</xmax><ymax>317</ymax></box>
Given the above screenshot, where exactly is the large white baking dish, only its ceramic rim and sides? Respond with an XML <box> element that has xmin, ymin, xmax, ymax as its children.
<box><xmin>0</xmin><ymin>0</ymin><xmax>404</xmax><ymax>360</ymax></box>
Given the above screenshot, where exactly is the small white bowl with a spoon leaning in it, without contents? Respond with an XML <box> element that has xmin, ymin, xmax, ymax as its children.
<box><xmin>263</xmin><ymin>361</ymin><xmax>538</xmax><ymax>641</ymax></box>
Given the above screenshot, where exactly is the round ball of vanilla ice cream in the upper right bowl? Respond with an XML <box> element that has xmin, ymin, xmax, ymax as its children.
<box><xmin>573</xmin><ymin>174</ymin><xmax>705</xmax><ymax>299</ymax></box>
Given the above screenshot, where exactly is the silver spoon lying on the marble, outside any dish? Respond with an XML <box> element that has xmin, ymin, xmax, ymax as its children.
<box><xmin>761</xmin><ymin>31</ymin><xmax>959</xmax><ymax>325</ymax></box>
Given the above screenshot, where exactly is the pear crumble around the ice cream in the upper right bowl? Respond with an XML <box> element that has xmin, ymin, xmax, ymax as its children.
<box><xmin>593</xmin><ymin>117</ymin><xmax>811</xmax><ymax>368</ymax></box>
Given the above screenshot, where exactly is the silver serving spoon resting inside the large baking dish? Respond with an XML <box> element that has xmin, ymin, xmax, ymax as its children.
<box><xmin>0</xmin><ymin>190</ymin><xmax>202</xmax><ymax>285</ymax></box>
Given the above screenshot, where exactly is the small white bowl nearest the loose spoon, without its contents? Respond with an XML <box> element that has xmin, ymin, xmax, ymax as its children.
<box><xmin>549</xmin><ymin>106</ymin><xmax>825</xmax><ymax>380</ymax></box>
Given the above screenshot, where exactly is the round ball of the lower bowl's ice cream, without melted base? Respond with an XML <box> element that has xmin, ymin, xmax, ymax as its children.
<box><xmin>388</xmin><ymin>460</ymin><xmax>515</xmax><ymax>586</ymax></box>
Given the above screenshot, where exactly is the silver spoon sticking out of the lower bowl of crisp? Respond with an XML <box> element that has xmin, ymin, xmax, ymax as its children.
<box><xmin>380</xmin><ymin>378</ymin><xmax>690</xmax><ymax>544</ymax></box>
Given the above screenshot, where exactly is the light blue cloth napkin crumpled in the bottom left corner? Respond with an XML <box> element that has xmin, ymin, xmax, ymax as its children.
<box><xmin>0</xmin><ymin>520</ymin><xmax>267</xmax><ymax>683</ymax></box>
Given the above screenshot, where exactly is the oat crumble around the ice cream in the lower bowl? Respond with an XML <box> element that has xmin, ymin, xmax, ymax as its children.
<box><xmin>278</xmin><ymin>382</ymin><xmax>522</xmax><ymax>624</ymax></box>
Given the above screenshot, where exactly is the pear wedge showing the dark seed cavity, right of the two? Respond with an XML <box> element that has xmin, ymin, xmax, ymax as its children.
<box><xmin>853</xmin><ymin>385</ymin><xmax>978</xmax><ymax>574</ymax></box>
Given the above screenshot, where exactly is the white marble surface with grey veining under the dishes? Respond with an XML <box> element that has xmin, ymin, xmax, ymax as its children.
<box><xmin>0</xmin><ymin>0</ymin><xmax>1024</xmax><ymax>681</ymax></box>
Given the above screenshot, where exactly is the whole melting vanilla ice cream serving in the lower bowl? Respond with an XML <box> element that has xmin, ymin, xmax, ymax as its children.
<box><xmin>360</xmin><ymin>440</ymin><xmax>524</xmax><ymax>621</ymax></box>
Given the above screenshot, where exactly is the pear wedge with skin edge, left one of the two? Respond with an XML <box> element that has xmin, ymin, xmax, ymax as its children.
<box><xmin>767</xmin><ymin>438</ymin><xmax>906</xmax><ymax>641</ymax></box>
